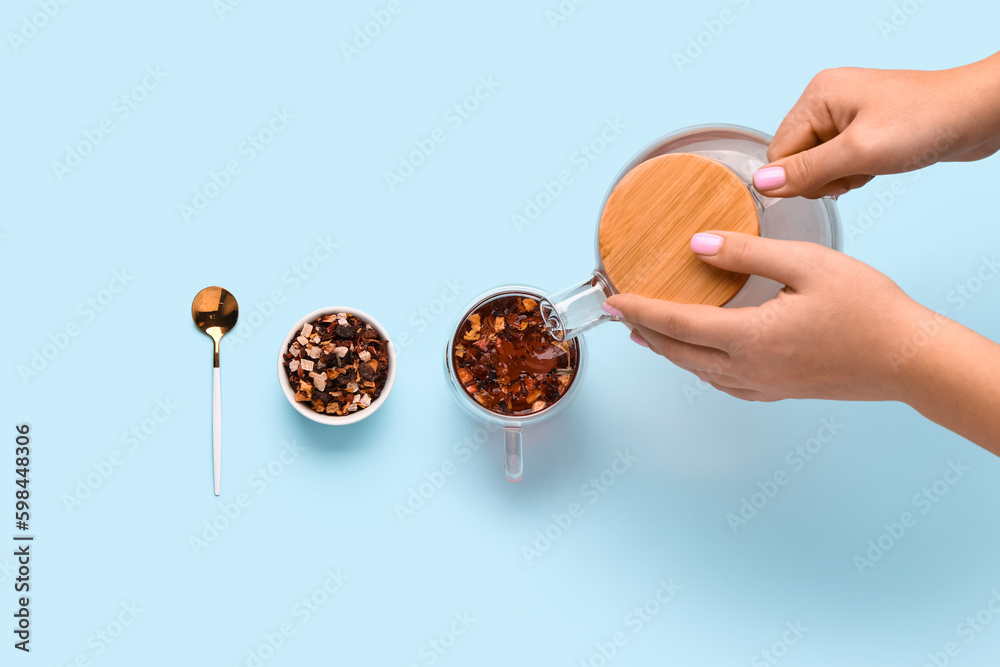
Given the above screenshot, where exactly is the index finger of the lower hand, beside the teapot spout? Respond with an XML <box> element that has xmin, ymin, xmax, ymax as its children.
<box><xmin>605</xmin><ymin>294</ymin><xmax>739</xmax><ymax>347</ymax></box>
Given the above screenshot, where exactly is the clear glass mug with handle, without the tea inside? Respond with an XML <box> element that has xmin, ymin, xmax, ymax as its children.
<box><xmin>444</xmin><ymin>285</ymin><xmax>586</xmax><ymax>482</ymax></box>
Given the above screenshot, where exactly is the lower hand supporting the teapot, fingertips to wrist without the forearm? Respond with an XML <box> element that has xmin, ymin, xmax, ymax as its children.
<box><xmin>606</xmin><ymin>232</ymin><xmax>935</xmax><ymax>401</ymax></box>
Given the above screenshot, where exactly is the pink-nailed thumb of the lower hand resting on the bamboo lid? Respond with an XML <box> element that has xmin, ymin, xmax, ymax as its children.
<box><xmin>691</xmin><ymin>231</ymin><xmax>833</xmax><ymax>289</ymax></box>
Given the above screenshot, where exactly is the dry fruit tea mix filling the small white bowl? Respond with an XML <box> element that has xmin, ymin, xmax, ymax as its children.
<box><xmin>282</xmin><ymin>313</ymin><xmax>389</xmax><ymax>417</ymax></box>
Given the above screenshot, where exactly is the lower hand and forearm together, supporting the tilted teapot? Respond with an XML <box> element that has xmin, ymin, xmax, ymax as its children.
<box><xmin>605</xmin><ymin>232</ymin><xmax>1000</xmax><ymax>455</ymax></box>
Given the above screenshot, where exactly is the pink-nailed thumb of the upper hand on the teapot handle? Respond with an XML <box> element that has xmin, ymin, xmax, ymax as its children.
<box><xmin>753</xmin><ymin>131</ymin><xmax>871</xmax><ymax>198</ymax></box>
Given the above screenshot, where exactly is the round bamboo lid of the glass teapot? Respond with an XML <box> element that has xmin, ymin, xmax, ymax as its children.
<box><xmin>598</xmin><ymin>153</ymin><xmax>760</xmax><ymax>306</ymax></box>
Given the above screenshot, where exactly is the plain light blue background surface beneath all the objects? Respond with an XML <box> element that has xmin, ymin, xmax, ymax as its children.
<box><xmin>0</xmin><ymin>0</ymin><xmax>1000</xmax><ymax>667</ymax></box>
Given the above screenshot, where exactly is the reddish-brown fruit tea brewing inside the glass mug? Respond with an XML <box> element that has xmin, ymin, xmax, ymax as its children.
<box><xmin>452</xmin><ymin>295</ymin><xmax>580</xmax><ymax>416</ymax></box>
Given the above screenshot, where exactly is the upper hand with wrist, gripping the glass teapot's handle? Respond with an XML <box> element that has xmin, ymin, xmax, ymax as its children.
<box><xmin>754</xmin><ymin>53</ymin><xmax>1000</xmax><ymax>198</ymax></box>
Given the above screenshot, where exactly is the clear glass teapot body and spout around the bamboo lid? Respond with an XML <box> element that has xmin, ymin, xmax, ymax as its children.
<box><xmin>539</xmin><ymin>125</ymin><xmax>843</xmax><ymax>340</ymax></box>
